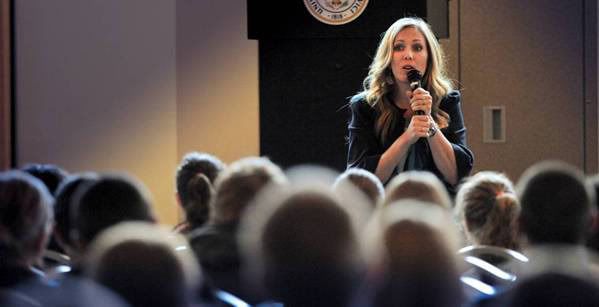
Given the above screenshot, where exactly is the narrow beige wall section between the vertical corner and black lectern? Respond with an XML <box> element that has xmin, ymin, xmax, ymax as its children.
<box><xmin>177</xmin><ymin>0</ymin><xmax>260</xmax><ymax>162</ymax></box>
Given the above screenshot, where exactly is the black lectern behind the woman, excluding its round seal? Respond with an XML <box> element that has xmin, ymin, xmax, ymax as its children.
<box><xmin>253</xmin><ymin>0</ymin><xmax>426</xmax><ymax>170</ymax></box>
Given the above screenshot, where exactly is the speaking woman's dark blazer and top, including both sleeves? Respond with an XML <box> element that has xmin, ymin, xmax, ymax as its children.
<box><xmin>347</xmin><ymin>91</ymin><xmax>474</xmax><ymax>194</ymax></box>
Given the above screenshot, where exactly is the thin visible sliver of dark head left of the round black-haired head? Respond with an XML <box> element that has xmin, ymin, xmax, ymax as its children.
<box><xmin>54</xmin><ymin>173</ymin><xmax>98</xmax><ymax>255</ymax></box>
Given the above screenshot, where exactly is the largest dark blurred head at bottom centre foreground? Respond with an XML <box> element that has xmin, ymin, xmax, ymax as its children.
<box><xmin>263</xmin><ymin>193</ymin><xmax>357</xmax><ymax>306</ymax></box>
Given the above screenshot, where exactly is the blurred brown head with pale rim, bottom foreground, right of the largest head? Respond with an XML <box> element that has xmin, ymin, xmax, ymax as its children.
<box><xmin>365</xmin><ymin>199</ymin><xmax>463</xmax><ymax>306</ymax></box>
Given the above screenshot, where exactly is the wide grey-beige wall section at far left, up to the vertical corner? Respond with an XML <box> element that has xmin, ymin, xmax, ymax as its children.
<box><xmin>15</xmin><ymin>0</ymin><xmax>178</xmax><ymax>223</ymax></box>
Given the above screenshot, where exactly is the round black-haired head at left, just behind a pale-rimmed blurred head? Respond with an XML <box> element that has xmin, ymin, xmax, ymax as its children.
<box><xmin>72</xmin><ymin>175</ymin><xmax>155</xmax><ymax>245</ymax></box>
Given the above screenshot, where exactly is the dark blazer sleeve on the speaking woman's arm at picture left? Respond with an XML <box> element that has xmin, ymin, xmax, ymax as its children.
<box><xmin>347</xmin><ymin>97</ymin><xmax>382</xmax><ymax>173</ymax></box>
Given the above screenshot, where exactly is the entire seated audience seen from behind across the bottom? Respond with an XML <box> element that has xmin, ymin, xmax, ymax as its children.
<box><xmin>0</xmin><ymin>156</ymin><xmax>599</xmax><ymax>307</ymax></box>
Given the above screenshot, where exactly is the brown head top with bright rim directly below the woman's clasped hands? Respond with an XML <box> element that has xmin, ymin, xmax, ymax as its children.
<box><xmin>385</xmin><ymin>171</ymin><xmax>451</xmax><ymax>209</ymax></box>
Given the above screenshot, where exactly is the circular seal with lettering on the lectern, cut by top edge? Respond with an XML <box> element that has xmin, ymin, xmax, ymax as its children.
<box><xmin>304</xmin><ymin>0</ymin><xmax>368</xmax><ymax>25</ymax></box>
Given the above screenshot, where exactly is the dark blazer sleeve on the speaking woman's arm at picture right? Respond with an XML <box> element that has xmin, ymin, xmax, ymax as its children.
<box><xmin>439</xmin><ymin>91</ymin><xmax>474</xmax><ymax>181</ymax></box>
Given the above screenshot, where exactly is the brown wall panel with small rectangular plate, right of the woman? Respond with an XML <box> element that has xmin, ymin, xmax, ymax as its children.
<box><xmin>460</xmin><ymin>0</ymin><xmax>584</xmax><ymax>179</ymax></box>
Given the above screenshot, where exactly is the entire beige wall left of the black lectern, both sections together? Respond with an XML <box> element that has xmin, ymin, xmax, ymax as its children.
<box><xmin>15</xmin><ymin>0</ymin><xmax>259</xmax><ymax>224</ymax></box>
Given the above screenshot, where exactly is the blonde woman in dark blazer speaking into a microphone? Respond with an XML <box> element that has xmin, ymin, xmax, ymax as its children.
<box><xmin>347</xmin><ymin>18</ymin><xmax>473</xmax><ymax>194</ymax></box>
